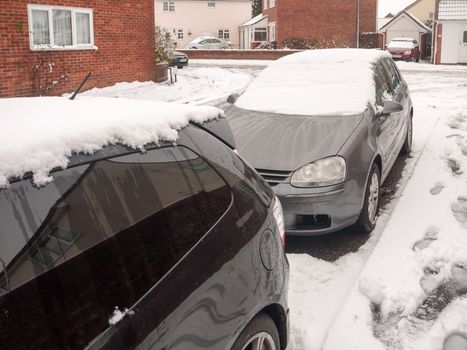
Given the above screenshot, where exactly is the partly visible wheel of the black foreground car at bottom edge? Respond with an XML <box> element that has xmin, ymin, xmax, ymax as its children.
<box><xmin>232</xmin><ymin>313</ymin><xmax>280</xmax><ymax>350</ymax></box>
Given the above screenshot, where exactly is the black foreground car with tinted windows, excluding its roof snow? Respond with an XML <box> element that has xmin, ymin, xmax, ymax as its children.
<box><xmin>0</xmin><ymin>98</ymin><xmax>288</xmax><ymax>350</ymax></box>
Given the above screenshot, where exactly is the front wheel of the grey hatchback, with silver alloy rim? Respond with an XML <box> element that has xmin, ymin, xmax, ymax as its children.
<box><xmin>355</xmin><ymin>163</ymin><xmax>381</xmax><ymax>234</ymax></box>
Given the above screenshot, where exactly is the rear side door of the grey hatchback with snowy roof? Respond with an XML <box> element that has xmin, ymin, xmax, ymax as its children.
<box><xmin>382</xmin><ymin>59</ymin><xmax>409</xmax><ymax>160</ymax></box>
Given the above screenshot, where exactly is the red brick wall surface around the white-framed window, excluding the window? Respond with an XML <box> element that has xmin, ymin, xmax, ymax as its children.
<box><xmin>0</xmin><ymin>0</ymin><xmax>155</xmax><ymax>97</ymax></box>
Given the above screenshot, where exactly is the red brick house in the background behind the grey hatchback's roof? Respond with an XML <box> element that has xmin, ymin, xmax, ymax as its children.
<box><xmin>252</xmin><ymin>0</ymin><xmax>377</xmax><ymax>47</ymax></box>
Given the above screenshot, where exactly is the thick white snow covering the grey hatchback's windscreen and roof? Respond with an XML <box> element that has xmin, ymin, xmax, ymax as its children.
<box><xmin>236</xmin><ymin>49</ymin><xmax>391</xmax><ymax>115</ymax></box>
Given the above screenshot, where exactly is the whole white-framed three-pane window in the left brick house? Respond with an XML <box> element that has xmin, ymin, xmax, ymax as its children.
<box><xmin>28</xmin><ymin>5</ymin><xmax>94</xmax><ymax>50</ymax></box>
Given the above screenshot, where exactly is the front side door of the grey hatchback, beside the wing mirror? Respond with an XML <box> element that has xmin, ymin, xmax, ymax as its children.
<box><xmin>374</xmin><ymin>62</ymin><xmax>394</xmax><ymax>174</ymax></box>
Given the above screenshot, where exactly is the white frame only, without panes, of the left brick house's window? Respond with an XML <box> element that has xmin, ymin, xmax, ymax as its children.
<box><xmin>28</xmin><ymin>4</ymin><xmax>95</xmax><ymax>51</ymax></box>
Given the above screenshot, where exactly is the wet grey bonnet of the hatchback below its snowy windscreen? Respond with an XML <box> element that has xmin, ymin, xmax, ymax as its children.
<box><xmin>225</xmin><ymin>106</ymin><xmax>363</xmax><ymax>171</ymax></box>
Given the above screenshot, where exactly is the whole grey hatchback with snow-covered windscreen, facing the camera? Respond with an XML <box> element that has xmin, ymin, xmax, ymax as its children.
<box><xmin>226</xmin><ymin>49</ymin><xmax>413</xmax><ymax>235</ymax></box>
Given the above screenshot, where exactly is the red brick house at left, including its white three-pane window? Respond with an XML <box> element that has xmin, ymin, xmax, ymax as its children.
<box><xmin>0</xmin><ymin>0</ymin><xmax>156</xmax><ymax>97</ymax></box>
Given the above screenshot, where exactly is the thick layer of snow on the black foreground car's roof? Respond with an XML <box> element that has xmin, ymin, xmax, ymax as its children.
<box><xmin>0</xmin><ymin>97</ymin><xmax>222</xmax><ymax>188</ymax></box>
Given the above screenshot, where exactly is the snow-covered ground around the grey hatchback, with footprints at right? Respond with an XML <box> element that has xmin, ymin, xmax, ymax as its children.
<box><xmin>80</xmin><ymin>60</ymin><xmax>467</xmax><ymax>350</ymax></box>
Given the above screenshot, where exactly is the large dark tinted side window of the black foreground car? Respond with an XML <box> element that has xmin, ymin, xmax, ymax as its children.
<box><xmin>0</xmin><ymin>147</ymin><xmax>231</xmax><ymax>349</ymax></box>
